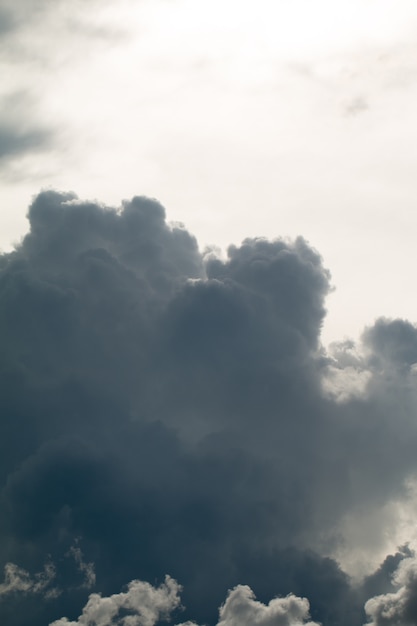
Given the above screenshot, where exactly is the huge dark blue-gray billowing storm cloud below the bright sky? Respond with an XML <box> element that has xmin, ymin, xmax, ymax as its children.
<box><xmin>0</xmin><ymin>191</ymin><xmax>417</xmax><ymax>626</ymax></box>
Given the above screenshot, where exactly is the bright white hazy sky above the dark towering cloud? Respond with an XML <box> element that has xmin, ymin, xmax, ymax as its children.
<box><xmin>0</xmin><ymin>0</ymin><xmax>417</xmax><ymax>342</ymax></box>
